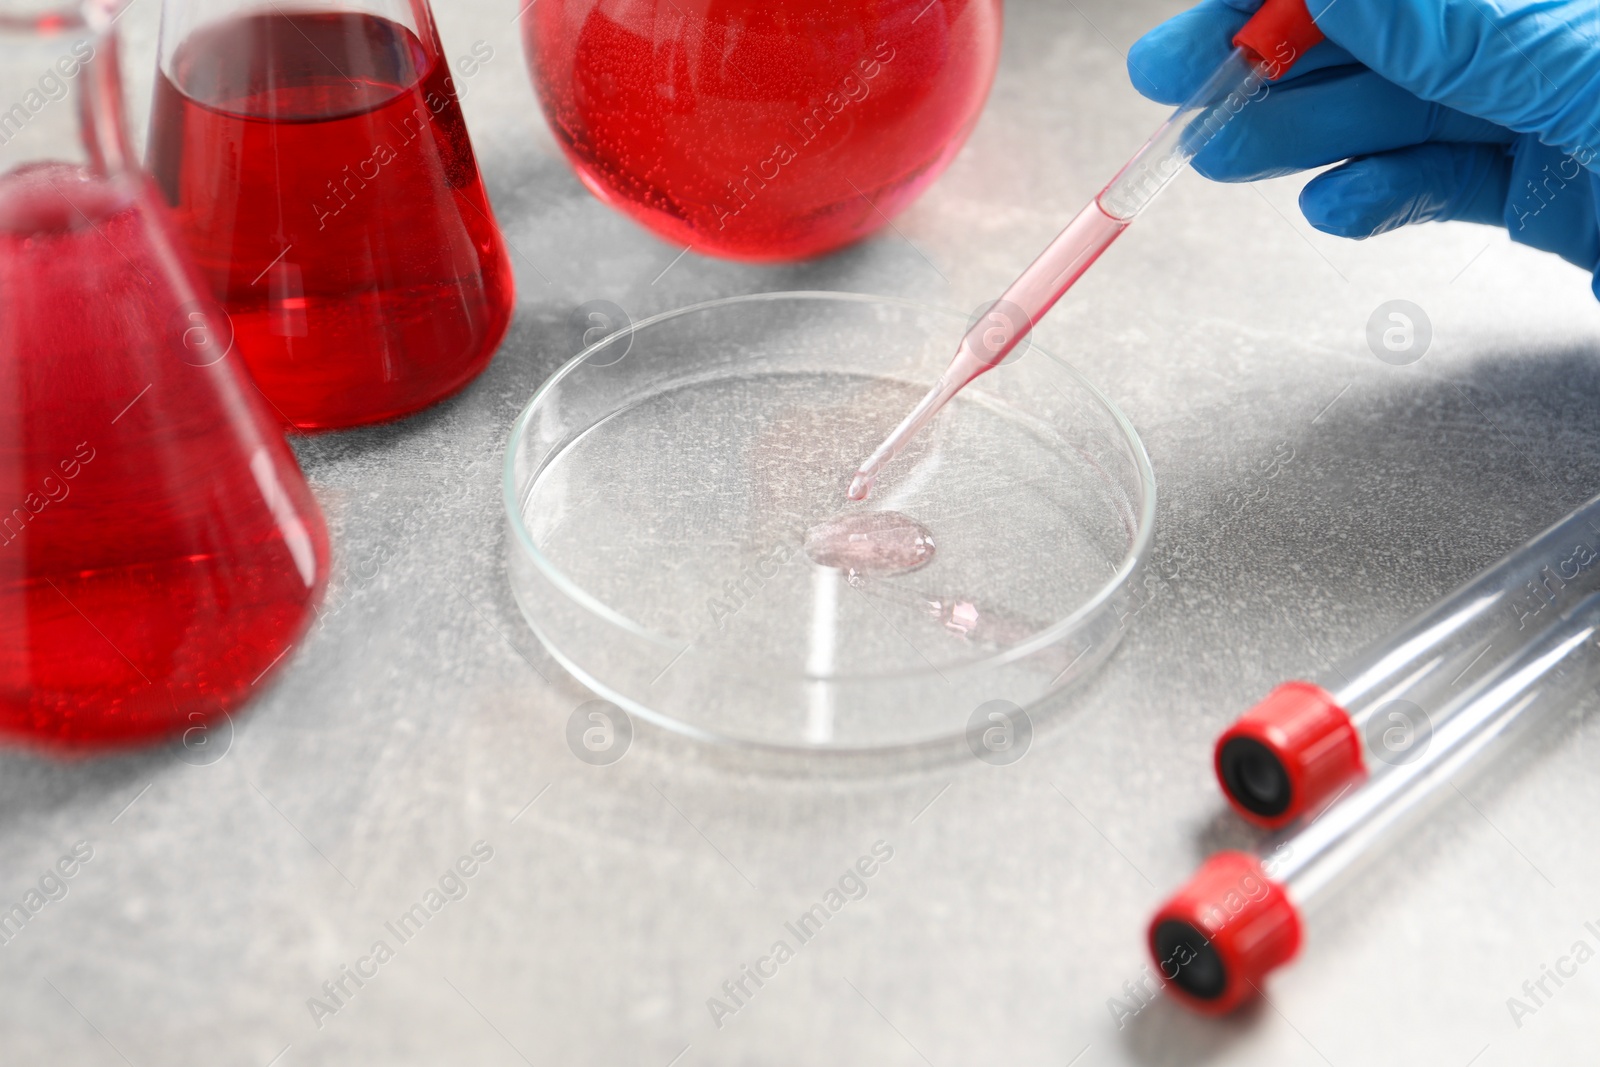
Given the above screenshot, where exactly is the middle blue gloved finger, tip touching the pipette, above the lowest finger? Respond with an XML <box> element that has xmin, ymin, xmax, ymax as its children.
<box><xmin>1194</xmin><ymin>66</ymin><xmax>1515</xmax><ymax>181</ymax></box>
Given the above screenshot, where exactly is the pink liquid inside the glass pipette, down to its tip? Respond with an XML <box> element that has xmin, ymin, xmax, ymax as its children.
<box><xmin>848</xmin><ymin>200</ymin><xmax>1128</xmax><ymax>501</ymax></box>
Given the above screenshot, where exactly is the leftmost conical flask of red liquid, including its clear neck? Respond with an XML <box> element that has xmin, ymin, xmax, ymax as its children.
<box><xmin>0</xmin><ymin>0</ymin><xmax>328</xmax><ymax>750</ymax></box>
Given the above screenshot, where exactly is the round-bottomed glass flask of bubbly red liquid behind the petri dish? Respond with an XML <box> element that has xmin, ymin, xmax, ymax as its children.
<box><xmin>522</xmin><ymin>0</ymin><xmax>1002</xmax><ymax>261</ymax></box>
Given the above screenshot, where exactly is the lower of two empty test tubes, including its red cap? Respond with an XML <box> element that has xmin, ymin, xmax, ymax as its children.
<box><xmin>1149</xmin><ymin>593</ymin><xmax>1600</xmax><ymax>1014</ymax></box>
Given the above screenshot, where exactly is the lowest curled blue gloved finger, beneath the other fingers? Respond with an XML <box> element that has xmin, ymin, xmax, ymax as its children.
<box><xmin>1301</xmin><ymin>144</ymin><xmax>1510</xmax><ymax>240</ymax></box>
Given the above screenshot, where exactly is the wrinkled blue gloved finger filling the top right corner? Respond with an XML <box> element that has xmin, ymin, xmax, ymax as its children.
<box><xmin>1309</xmin><ymin>0</ymin><xmax>1600</xmax><ymax>165</ymax></box>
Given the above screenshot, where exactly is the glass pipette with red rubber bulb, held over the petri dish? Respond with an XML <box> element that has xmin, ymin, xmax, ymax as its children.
<box><xmin>850</xmin><ymin>0</ymin><xmax>1322</xmax><ymax>501</ymax></box>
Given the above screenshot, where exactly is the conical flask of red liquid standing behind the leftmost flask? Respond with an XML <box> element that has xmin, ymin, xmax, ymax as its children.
<box><xmin>149</xmin><ymin>0</ymin><xmax>515</xmax><ymax>430</ymax></box>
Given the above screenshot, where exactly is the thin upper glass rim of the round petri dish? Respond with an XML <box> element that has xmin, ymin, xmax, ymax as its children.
<box><xmin>501</xmin><ymin>290</ymin><xmax>1157</xmax><ymax>681</ymax></box>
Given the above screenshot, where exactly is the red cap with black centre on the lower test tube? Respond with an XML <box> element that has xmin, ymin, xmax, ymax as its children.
<box><xmin>1149</xmin><ymin>853</ymin><xmax>1302</xmax><ymax>1016</ymax></box>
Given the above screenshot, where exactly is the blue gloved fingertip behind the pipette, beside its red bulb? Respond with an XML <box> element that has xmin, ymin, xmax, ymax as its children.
<box><xmin>1128</xmin><ymin>0</ymin><xmax>1354</xmax><ymax>106</ymax></box>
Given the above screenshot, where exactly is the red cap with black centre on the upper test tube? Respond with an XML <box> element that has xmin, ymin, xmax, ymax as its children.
<box><xmin>1213</xmin><ymin>681</ymin><xmax>1366</xmax><ymax>830</ymax></box>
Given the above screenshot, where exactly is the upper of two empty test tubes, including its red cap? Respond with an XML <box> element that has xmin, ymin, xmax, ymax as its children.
<box><xmin>1214</xmin><ymin>496</ymin><xmax>1600</xmax><ymax>829</ymax></box>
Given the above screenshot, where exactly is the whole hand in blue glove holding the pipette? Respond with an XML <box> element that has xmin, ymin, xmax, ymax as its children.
<box><xmin>1128</xmin><ymin>0</ymin><xmax>1600</xmax><ymax>296</ymax></box>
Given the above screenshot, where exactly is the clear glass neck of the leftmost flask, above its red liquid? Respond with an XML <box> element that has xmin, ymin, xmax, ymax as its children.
<box><xmin>0</xmin><ymin>0</ymin><xmax>136</xmax><ymax>178</ymax></box>
